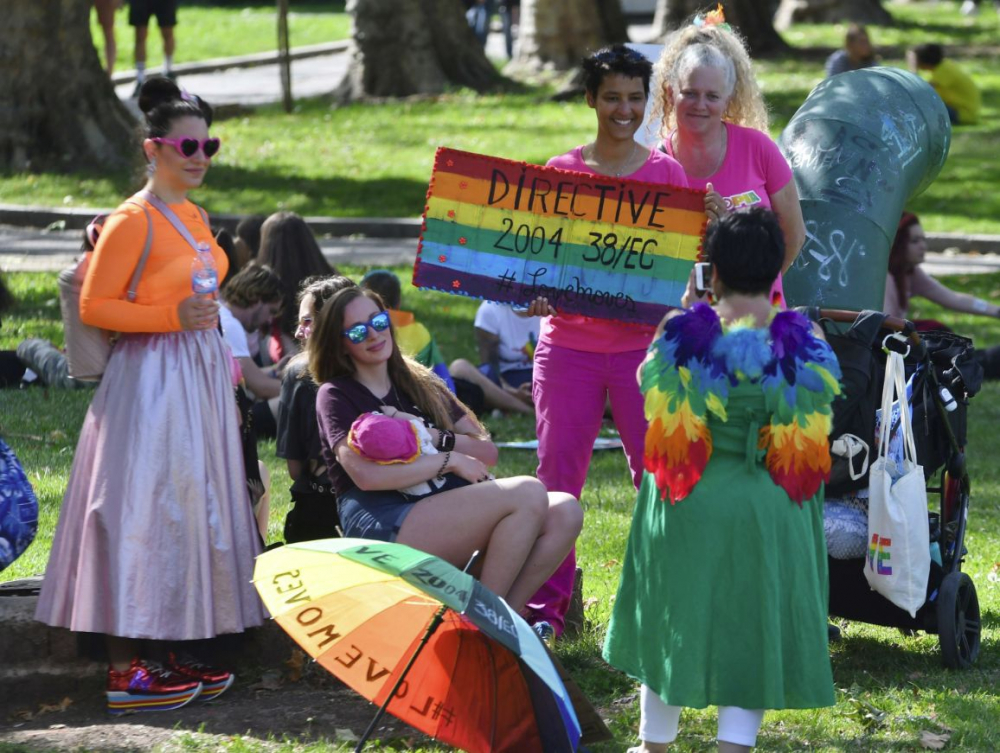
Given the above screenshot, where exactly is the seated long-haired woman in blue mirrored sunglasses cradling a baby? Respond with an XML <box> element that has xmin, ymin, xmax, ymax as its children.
<box><xmin>307</xmin><ymin>288</ymin><xmax>583</xmax><ymax>610</ymax></box>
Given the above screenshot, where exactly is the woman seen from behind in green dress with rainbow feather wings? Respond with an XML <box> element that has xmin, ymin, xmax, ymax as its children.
<box><xmin>604</xmin><ymin>208</ymin><xmax>840</xmax><ymax>753</ymax></box>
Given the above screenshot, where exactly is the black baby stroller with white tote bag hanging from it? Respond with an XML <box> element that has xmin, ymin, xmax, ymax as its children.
<box><xmin>803</xmin><ymin>308</ymin><xmax>982</xmax><ymax>669</ymax></box>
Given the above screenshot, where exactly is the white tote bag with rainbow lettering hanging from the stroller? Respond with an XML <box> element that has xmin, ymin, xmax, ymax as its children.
<box><xmin>865</xmin><ymin>344</ymin><xmax>931</xmax><ymax>617</ymax></box>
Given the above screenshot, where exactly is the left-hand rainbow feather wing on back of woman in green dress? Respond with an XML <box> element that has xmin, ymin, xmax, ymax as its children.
<box><xmin>641</xmin><ymin>305</ymin><xmax>729</xmax><ymax>504</ymax></box>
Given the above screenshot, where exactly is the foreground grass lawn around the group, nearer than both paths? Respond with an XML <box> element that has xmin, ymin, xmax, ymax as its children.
<box><xmin>0</xmin><ymin>268</ymin><xmax>1000</xmax><ymax>753</ymax></box>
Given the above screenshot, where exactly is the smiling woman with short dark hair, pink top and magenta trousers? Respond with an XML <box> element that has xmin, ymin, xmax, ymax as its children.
<box><xmin>528</xmin><ymin>45</ymin><xmax>687</xmax><ymax>634</ymax></box>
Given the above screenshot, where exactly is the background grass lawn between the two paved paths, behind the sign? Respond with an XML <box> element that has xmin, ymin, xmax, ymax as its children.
<box><xmin>0</xmin><ymin>2</ymin><xmax>1000</xmax><ymax>234</ymax></box>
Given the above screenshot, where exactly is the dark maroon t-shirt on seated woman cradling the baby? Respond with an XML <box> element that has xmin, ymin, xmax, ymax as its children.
<box><xmin>316</xmin><ymin>377</ymin><xmax>465</xmax><ymax>495</ymax></box>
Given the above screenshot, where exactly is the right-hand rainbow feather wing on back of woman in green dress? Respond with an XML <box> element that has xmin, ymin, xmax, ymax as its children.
<box><xmin>759</xmin><ymin>311</ymin><xmax>840</xmax><ymax>505</ymax></box>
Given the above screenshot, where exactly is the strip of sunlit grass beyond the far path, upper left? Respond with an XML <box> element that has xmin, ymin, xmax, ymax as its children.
<box><xmin>90</xmin><ymin>0</ymin><xmax>350</xmax><ymax>71</ymax></box>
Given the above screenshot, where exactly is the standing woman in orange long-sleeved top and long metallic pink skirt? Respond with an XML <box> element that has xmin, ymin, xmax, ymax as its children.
<box><xmin>36</xmin><ymin>78</ymin><xmax>263</xmax><ymax>712</ymax></box>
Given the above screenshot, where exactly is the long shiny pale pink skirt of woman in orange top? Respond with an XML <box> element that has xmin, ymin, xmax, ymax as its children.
<box><xmin>35</xmin><ymin>330</ymin><xmax>264</xmax><ymax>640</ymax></box>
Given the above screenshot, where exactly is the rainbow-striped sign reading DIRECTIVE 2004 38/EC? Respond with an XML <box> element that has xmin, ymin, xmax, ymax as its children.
<box><xmin>413</xmin><ymin>148</ymin><xmax>705</xmax><ymax>324</ymax></box>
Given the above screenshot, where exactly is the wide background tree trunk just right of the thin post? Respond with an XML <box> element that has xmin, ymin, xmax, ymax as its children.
<box><xmin>336</xmin><ymin>0</ymin><xmax>504</xmax><ymax>101</ymax></box>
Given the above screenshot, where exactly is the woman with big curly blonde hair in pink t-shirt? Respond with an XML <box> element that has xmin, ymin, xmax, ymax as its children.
<box><xmin>652</xmin><ymin>14</ymin><xmax>805</xmax><ymax>299</ymax></box>
